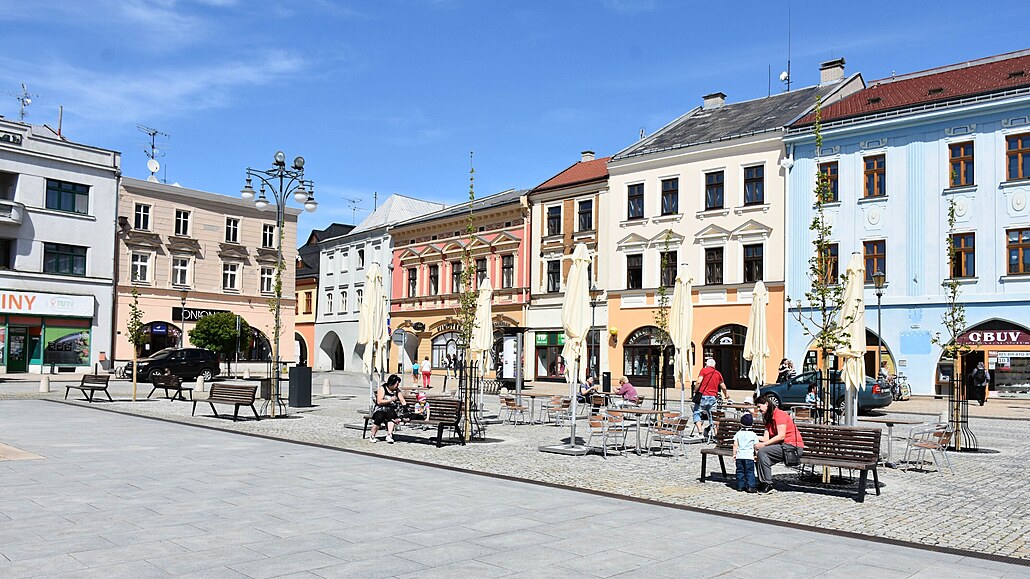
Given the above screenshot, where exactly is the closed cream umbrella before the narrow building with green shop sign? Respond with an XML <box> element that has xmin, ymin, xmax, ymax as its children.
<box><xmin>561</xmin><ymin>243</ymin><xmax>590</xmax><ymax>446</ymax></box>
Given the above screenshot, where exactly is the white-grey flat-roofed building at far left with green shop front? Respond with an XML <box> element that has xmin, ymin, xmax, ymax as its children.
<box><xmin>0</xmin><ymin>117</ymin><xmax>121</xmax><ymax>374</ymax></box>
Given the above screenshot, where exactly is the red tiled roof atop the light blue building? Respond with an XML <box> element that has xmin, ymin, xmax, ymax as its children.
<box><xmin>793</xmin><ymin>50</ymin><xmax>1030</xmax><ymax>127</ymax></box>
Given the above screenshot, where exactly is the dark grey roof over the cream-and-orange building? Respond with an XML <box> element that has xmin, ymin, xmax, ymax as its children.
<box><xmin>612</xmin><ymin>82</ymin><xmax>840</xmax><ymax>161</ymax></box>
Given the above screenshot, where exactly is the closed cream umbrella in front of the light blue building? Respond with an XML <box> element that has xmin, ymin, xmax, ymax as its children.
<box><xmin>833</xmin><ymin>251</ymin><xmax>865</xmax><ymax>424</ymax></box>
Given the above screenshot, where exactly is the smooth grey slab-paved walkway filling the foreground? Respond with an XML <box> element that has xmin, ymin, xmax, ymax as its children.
<box><xmin>0</xmin><ymin>401</ymin><xmax>1030</xmax><ymax>578</ymax></box>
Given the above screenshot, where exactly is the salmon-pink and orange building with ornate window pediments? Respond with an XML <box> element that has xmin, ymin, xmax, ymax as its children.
<box><xmin>390</xmin><ymin>190</ymin><xmax>530</xmax><ymax>378</ymax></box>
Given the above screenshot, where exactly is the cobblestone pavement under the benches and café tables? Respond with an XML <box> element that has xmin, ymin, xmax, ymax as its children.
<box><xmin>6</xmin><ymin>376</ymin><xmax>1030</xmax><ymax>559</ymax></box>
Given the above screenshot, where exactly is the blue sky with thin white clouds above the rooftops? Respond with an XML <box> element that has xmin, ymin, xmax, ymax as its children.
<box><xmin>0</xmin><ymin>0</ymin><xmax>1030</xmax><ymax>238</ymax></box>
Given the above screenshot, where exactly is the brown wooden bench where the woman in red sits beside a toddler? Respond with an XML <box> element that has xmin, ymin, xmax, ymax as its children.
<box><xmin>701</xmin><ymin>419</ymin><xmax>881</xmax><ymax>503</ymax></box>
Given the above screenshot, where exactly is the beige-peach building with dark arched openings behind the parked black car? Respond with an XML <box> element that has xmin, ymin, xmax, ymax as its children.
<box><xmin>114</xmin><ymin>178</ymin><xmax>300</xmax><ymax>363</ymax></box>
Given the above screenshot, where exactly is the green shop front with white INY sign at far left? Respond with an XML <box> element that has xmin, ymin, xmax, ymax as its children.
<box><xmin>0</xmin><ymin>290</ymin><xmax>95</xmax><ymax>374</ymax></box>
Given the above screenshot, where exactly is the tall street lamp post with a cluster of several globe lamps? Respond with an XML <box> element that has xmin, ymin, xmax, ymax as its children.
<box><xmin>240</xmin><ymin>150</ymin><xmax>318</xmax><ymax>417</ymax></box>
